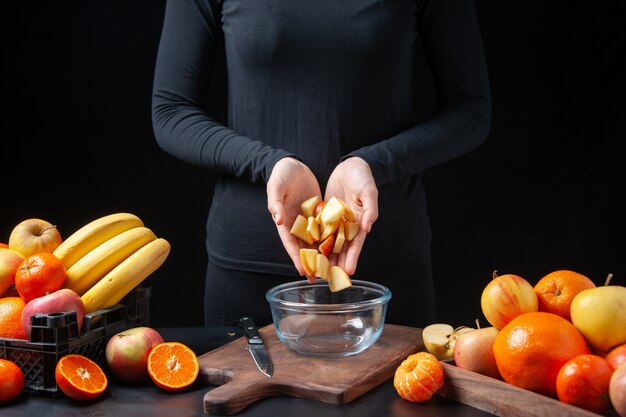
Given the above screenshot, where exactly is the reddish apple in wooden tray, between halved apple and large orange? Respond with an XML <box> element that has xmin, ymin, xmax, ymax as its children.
<box><xmin>454</xmin><ymin>327</ymin><xmax>502</xmax><ymax>379</ymax></box>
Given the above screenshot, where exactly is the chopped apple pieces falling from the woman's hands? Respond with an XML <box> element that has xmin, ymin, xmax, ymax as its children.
<box><xmin>291</xmin><ymin>196</ymin><xmax>359</xmax><ymax>292</ymax></box>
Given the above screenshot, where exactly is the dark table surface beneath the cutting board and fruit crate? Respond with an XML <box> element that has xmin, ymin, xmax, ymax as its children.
<box><xmin>0</xmin><ymin>327</ymin><xmax>490</xmax><ymax>417</ymax></box>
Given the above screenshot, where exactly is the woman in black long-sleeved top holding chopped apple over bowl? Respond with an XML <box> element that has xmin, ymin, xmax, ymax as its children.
<box><xmin>153</xmin><ymin>0</ymin><xmax>491</xmax><ymax>326</ymax></box>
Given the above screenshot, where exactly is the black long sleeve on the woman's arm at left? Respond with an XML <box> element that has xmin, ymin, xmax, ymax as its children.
<box><xmin>152</xmin><ymin>0</ymin><xmax>291</xmax><ymax>183</ymax></box>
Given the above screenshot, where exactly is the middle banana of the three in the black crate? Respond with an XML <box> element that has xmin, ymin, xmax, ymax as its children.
<box><xmin>64</xmin><ymin>226</ymin><xmax>156</xmax><ymax>295</ymax></box>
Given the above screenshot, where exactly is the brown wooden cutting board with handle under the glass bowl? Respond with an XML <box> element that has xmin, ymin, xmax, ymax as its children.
<box><xmin>198</xmin><ymin>324</ymin><xmax>424</xmax><ymax>415</ymax></box>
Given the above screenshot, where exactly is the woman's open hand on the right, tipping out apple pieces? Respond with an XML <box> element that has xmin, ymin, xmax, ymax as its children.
<box><xmin>324</xmin><ymin>157</ymin><xmax>378</xmax><ymax>275</ymax></box>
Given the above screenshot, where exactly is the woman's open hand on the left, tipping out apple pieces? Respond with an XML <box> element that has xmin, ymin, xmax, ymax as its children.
<box><xmin>267</xmin><ymin>158</ymin><xmax>322</xmax><ymax>282</ymax></box>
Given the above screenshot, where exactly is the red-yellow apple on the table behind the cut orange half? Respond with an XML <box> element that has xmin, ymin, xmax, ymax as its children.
<box><xmin>105</xmin><ymin>327</ymin><xmax>163</xmax><ymax>383</ymax></box>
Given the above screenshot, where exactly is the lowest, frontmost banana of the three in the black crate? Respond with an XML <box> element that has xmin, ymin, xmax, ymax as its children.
<box><xmin>81</xmin><ymin>238</ymin><xmax>170</xmax><ymax>314</ymax></box>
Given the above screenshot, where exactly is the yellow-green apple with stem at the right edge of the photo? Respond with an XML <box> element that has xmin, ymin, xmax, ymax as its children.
<box><xmin>570</xmin><ymin>276</ymin><xmax>626</xmax><ymax>353</ymax></box>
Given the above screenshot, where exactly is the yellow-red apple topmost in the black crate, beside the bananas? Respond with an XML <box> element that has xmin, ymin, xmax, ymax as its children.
<box><xmin>9</xmin><ymin>219</ymin><xmax>62</xmax><ymax>257</ymax></box>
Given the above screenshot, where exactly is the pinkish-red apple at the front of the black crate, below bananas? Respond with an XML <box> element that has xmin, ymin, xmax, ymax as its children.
<box><xmin>22</xmin><ymin>288</ymin><xmax>85</xmax><ymax>337</ymax></box>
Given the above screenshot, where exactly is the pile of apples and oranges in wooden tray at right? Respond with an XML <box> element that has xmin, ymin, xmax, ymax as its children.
<box><xmin>414</xmin><ymin>270</ymin><xmax>626</xmax><ymax>417</ymax></box>
